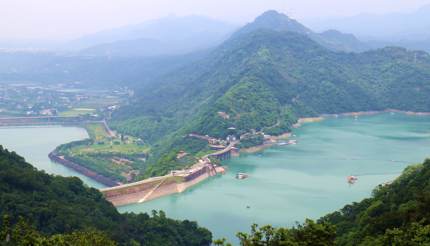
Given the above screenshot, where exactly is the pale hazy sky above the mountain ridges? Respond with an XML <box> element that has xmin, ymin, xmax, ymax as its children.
<box><xmin>0</xmin><ymin>0</ymin><xmax>430</xmax><ymax>39</ymax></box>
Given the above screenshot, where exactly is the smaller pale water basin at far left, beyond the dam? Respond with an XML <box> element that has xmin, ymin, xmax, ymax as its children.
<box><xmin>0</xmin><ymin>126</ymin><xmax>104</xmax><ymax>188</ymax></box>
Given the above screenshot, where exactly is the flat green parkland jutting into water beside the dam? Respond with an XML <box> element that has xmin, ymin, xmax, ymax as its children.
<box><xmin>56</xmin><ymin>123</ymin><xmax>149</xmax><ymax>182</ymax></box>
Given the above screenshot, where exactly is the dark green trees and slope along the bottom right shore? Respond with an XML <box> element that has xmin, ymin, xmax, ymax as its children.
<box><xmin>214</xmin><ymin>159</ymin><xmax>430</xmax><ymax>246</ymax></box>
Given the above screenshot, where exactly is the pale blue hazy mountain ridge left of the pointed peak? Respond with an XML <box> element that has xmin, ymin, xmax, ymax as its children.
<box><xmin>69</xmin><ymin>16</ymin><xmax>237</xmax><ymax>56</ymax></box>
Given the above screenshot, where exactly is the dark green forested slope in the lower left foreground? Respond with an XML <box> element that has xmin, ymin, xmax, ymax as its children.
<box><xmin>0</xmin><ymin>146</ymin><xmax>211</xmax><ymax>246</ymax></box>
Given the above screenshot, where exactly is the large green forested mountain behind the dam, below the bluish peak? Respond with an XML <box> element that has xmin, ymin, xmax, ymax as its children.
<box><xmin>111</xmin><ymin>10</ymin><xmax>430</xmax><ymax>178</ymax></box>
